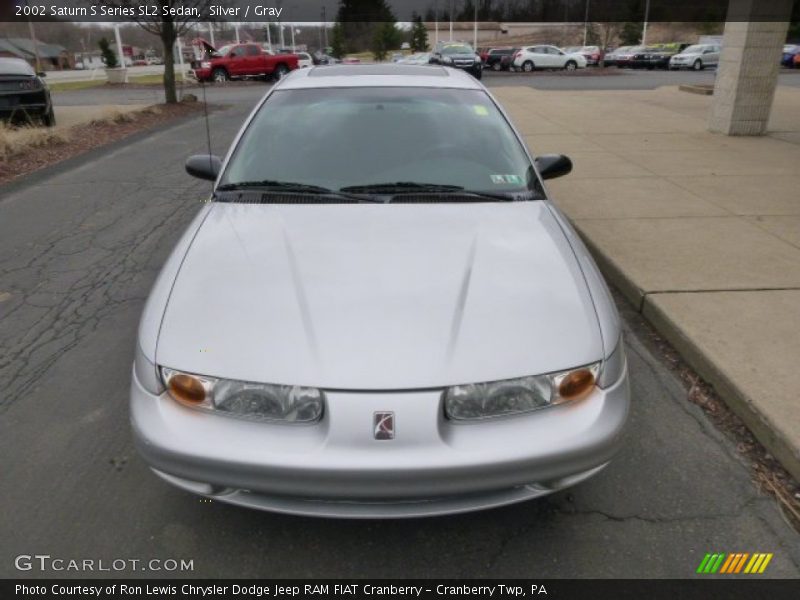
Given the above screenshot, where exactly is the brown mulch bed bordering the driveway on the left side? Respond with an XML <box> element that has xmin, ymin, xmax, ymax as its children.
<box><xmin>0</xmin><ymin>102</ymin><xmax>209</xmax><ymax>184</ymax></box>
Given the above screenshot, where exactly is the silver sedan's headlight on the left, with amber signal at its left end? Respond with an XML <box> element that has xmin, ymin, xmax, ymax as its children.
<box><xmin>161</xmin><ymin>368</ymin><xmax>324</xmax><ymax>423</ymax></box>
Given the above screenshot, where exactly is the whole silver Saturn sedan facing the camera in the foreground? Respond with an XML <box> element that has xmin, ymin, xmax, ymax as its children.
<box><xmin>131</xmin><ymin>65</ymin><xmax>629</xmax><ymax>517</ymax></box>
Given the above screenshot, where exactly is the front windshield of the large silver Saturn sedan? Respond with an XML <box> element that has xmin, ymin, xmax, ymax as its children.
<box><xmin>220</xmin><ymin>87</ymin><xmax>537</xmax><ymax>197</ymax></box>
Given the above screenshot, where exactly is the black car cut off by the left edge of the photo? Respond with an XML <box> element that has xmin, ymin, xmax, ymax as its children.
<box><xmin>0</xmin><ymin>57</ymin><xmax>56</xmax><ymax>127</ymax></box>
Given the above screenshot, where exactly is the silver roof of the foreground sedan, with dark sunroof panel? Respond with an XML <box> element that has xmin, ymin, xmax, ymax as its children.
<box><xmin>276</xmin><ymin>63</ymin><xmax>481</xmax><ymax>90</ymax></box>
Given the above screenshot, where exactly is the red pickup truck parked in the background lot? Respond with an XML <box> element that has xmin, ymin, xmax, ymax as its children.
<box><xmin>192</xmin><ymin>44</ymin><xmax>297</xmax><ymax>82</ymax></box>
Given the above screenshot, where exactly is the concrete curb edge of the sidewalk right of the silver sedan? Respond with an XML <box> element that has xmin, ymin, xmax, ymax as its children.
<box><xmin>573</xmin><ymin>222</ymin><xmax>800</xmax><ymax>481</ymax></box>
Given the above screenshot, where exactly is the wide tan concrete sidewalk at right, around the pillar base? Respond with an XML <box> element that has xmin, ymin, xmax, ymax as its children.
<box><xmin>492</xmin><ymin>87</ymin><xmax>800</xmax><ymax>479</ymax></box>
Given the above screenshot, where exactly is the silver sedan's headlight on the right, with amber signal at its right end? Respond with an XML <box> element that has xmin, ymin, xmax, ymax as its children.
<box><xmin>444</xmin><ymin>363</ymin><xmax>600</xmax><ymax>420</ymax></box>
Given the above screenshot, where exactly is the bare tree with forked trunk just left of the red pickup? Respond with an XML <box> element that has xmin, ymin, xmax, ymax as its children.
<box><xmin>93</xmin><ymin>0</ymin><xmax>229</xmax><ymax>104</ymax></box>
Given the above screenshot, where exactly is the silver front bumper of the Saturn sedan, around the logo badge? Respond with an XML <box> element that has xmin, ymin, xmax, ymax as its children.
<box><xmin>131</xmin><ymin>370</ymin><xmax>629</xmax><ymax>518</ymax></box>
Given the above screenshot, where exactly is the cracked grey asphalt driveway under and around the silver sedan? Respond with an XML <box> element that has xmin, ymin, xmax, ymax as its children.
<box><xmin>0</xmin><ymin>86</ymin><xmax>800</xmax><ymax>578</ymax></box>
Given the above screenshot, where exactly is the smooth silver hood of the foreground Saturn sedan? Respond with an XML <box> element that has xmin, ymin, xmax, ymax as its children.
<box><xmin>156</xmin><ymin>201</ymin><xmax>602</xmax><ymax>389</ymax></box>
